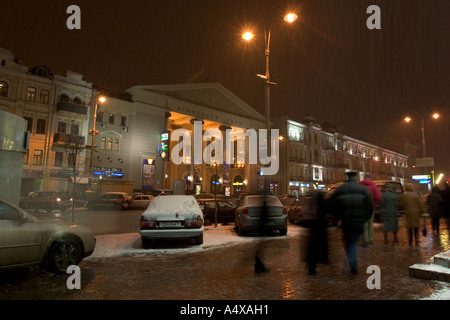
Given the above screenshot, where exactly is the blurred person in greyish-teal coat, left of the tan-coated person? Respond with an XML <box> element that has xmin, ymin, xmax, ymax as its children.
<box><xmin>379</xmin><ymin>185</ymin><xmax>399</xmax><ymax>244</ymax></box>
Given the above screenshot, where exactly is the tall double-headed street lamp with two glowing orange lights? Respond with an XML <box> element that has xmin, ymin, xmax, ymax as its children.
<box><xmin>242</xmin><ymin>12</ymin><xmax>298</xmax><ymax>193</ymax></box>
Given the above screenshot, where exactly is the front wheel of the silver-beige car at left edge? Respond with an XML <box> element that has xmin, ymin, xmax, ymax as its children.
<box><xmin>47</xmin><ymin>239</ymin><xmax>81</xmax><ymax>273</ymax></box>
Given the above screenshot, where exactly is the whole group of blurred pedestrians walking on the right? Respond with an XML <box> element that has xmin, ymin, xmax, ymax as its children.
<box><xmin>306</xmin><ymin>172</ymin><xmax>450</xmax><ymax>275</ymax></box>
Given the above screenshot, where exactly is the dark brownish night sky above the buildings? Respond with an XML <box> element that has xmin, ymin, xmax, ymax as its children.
<box><xmin>0</xmin><ymin>0</ymin><xmax>450</xmax><ymax>174</ymax></box>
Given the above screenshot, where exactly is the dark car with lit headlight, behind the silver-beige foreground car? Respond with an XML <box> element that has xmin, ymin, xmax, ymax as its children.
<box><xmin>19</xmin><ymin>191</ymin><xmax>73</xmax><ymax>213</ymax></box>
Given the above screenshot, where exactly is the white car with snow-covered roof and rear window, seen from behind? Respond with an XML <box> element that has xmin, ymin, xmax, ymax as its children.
<box><xmin>139</xmin><ymin>195</ymin><xmax>204</xmax><ymax>247</ymax></box>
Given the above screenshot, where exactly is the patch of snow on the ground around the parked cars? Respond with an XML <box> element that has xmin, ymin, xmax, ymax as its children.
<box><xmin>86</xmin><ymin>225</ymin><xmax>307</xmax><ymax>260</ymax></box>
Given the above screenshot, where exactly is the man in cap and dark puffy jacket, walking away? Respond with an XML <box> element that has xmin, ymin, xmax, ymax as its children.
<box><xmin>329</xmin><ymin>171</ymin><xmax>374</xmax><ymax>274</ymax></box>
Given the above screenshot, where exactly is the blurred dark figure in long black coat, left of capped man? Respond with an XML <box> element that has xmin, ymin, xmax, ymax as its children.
<box><xmin>306</xmin><ymin>191</ymin><xmax>328</xmax><ymax>275</ymax></box>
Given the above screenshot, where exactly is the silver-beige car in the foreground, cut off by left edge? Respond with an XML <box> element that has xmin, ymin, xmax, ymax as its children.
<box><xmin>0</xmin><ymin>200</ymin><xmax>96</xmax><ymax>273</ymax></box>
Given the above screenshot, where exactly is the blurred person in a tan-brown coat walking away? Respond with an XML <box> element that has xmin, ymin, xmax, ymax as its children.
<box><xmin>399</xmin><ymin>183</ymin><xmax>425</xmax><ymax>245</ymax></box>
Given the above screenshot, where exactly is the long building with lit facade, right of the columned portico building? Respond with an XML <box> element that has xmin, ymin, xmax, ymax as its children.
<box><xmin>273</xmin><ymin>116</ymin><xmax>410</xmax><ymax>195</ymax></box>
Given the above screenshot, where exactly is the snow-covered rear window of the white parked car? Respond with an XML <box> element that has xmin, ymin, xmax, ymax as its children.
<box><xmin>146</xmin><ymin>196</ymin><xmax>200</xmax><ymax>212</ymax></box>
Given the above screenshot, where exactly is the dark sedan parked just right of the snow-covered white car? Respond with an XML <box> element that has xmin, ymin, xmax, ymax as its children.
<box><xmin>234</xmin><ymin>195</ymin><xmax>287</xmax><ymax>235</ymax></box>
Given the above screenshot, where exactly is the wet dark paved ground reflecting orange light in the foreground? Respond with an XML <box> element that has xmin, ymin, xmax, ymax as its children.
<box><xmin>0</xmin><ymin>216</ymin><xmax>450</xmax><ymax>301</ymax></box>
